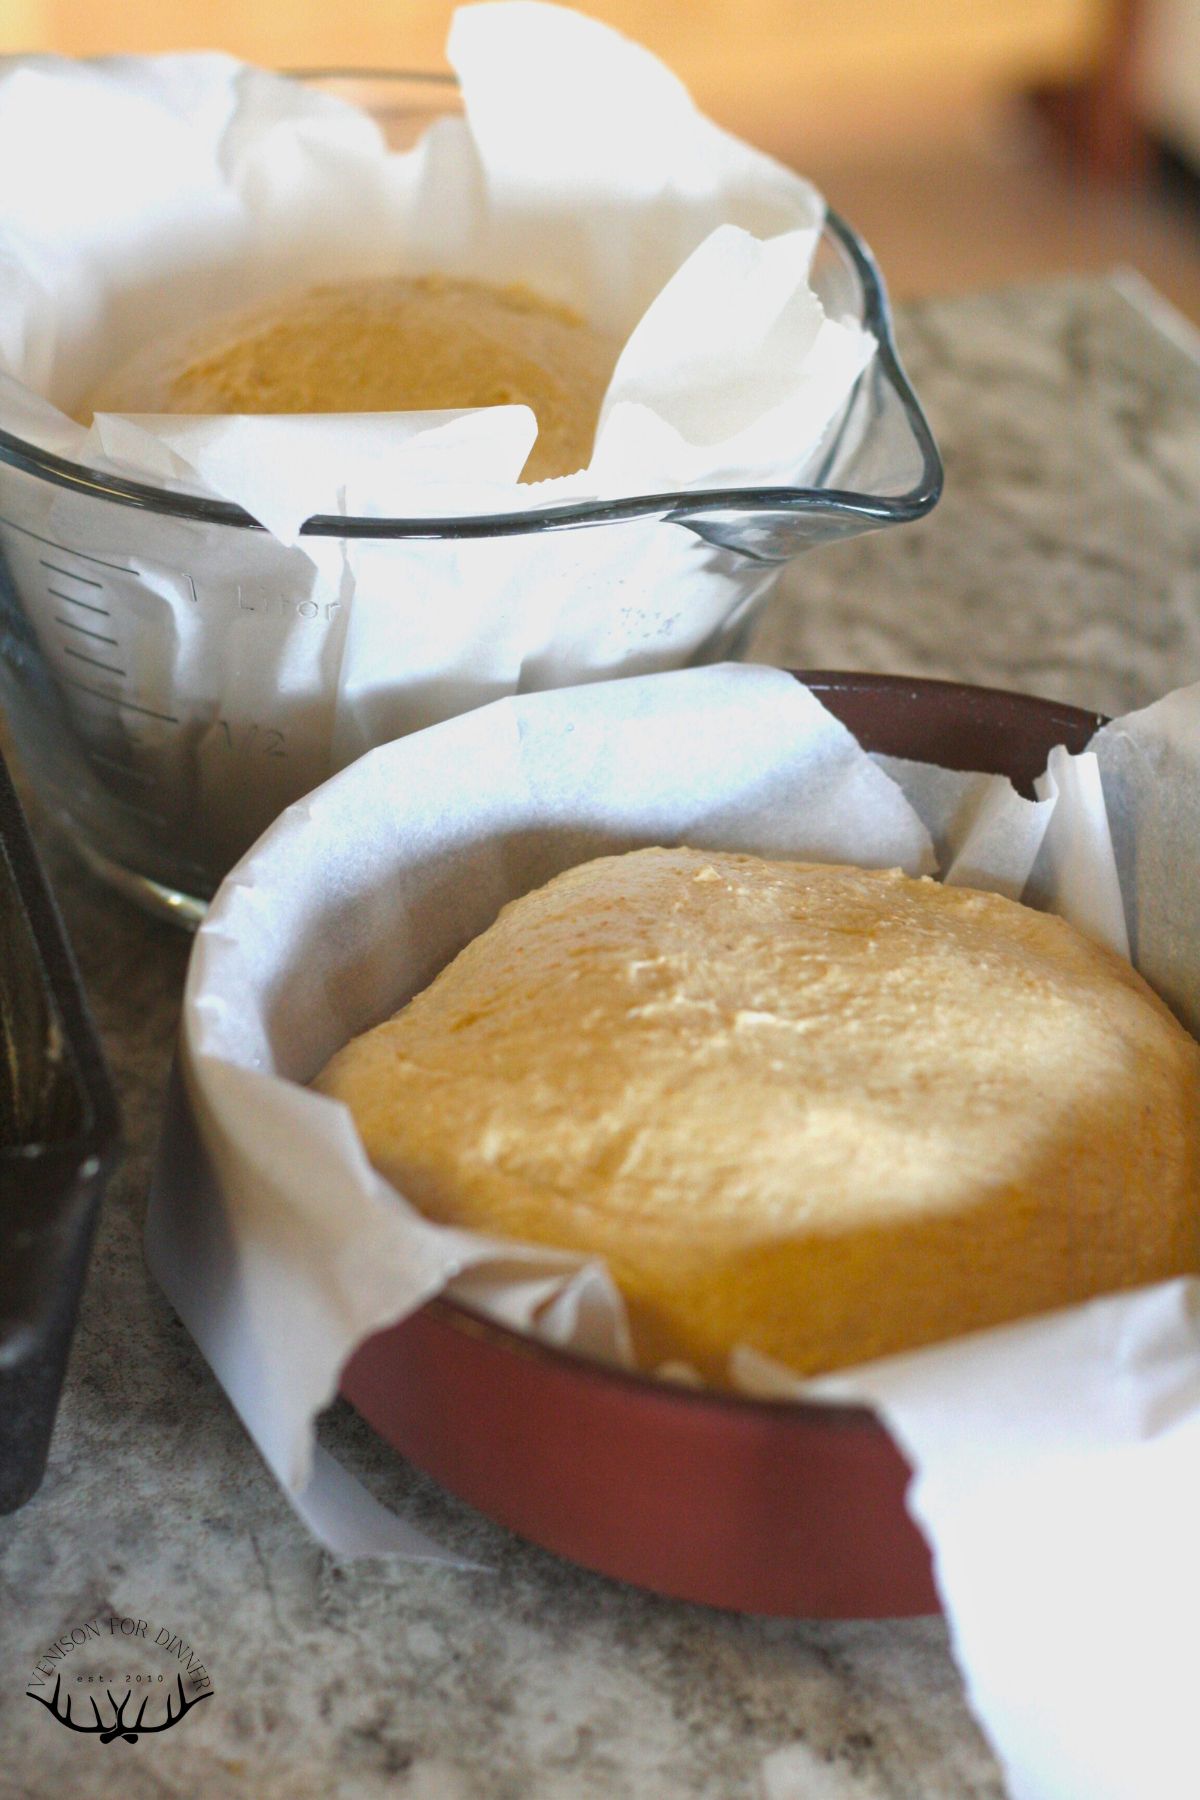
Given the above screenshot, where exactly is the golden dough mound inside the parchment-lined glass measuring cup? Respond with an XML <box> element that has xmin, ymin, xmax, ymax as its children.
<box><xmin>90</xmin><ymin>275</ymin><xmax>617</xmax><ymax>481</ymax></box>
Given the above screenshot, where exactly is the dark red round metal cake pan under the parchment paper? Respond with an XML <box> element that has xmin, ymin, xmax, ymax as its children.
<box><xmin>342</xmin><ymin>670</ymin><xmax>1103</xmax><ymax>1618</ymax></box>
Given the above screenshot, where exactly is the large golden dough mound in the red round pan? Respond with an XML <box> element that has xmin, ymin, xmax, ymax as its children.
<box><xmin>317</xmin><ymin>850</ymin><xmax>1200</xmax><ymax>1382</ymax></box>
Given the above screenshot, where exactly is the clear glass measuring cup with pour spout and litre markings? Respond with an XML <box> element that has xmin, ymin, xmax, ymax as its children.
<box><xmin>0</xmin><ymin>72</ymin><xmax>941</xmax><ymax>922</ymax></box>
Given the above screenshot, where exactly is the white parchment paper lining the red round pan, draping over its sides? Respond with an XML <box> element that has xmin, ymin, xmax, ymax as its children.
<box><xmin>148</xmin><ymin>666</ymin><xmax>1200</xmax><ymax>1800</ymax></box>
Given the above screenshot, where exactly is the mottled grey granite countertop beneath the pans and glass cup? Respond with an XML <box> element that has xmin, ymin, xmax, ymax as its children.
<box><xmin>0</xmin><ymin>279</ymin><xmax>1200</xmax><ymax>1800</ymax></box>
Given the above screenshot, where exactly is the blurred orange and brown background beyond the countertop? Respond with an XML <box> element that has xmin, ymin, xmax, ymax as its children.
<box><xmin>0</xmin><ymin>0</ymin><xmax>1200</xmax><ymax>324</ymax></box>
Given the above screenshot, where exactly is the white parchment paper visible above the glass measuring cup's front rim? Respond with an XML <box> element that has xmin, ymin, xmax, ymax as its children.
<box><xmin>0</xmin><ymin>0</ymin><xmax>873</xmax><ymax>522</ymax></box>
